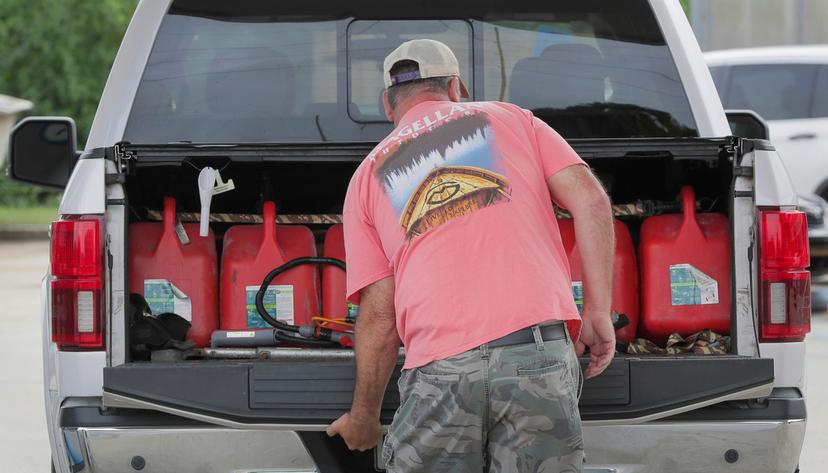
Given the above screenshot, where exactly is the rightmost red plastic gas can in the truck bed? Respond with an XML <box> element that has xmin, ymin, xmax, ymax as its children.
<box><xmin>639</xmin><ymin>186</ymin><xmax>730</xmax><ymax>342</ymax></box>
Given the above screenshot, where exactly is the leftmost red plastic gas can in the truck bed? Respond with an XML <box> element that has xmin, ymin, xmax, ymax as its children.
<box><xmin>129</xmin><ymin>197</ymin><xmax>218</xmax><ymax>347</ymax></box>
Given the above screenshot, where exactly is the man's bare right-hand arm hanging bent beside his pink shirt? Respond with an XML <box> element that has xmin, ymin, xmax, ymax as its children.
<box><xmin>547</xmin><ymin>165</ymin><xmax>615</xmax><ymax>378</ymax></box>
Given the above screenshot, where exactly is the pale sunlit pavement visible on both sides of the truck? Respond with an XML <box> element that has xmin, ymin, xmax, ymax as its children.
<box><xmin>0</xmin><ymin>241</ymin><xmax>828</xmax><ymax>473</ymax></box>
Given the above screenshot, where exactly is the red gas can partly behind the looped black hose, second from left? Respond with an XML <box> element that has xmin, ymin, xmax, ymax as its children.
<box><xmin>221</xmin><ymin>202</ymin><xmax>319</xmax><ymax>330</ymax></box>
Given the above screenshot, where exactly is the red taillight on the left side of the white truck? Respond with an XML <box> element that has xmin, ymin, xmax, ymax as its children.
<box><xmin>51</xmin><ymin>215</ymin><xmax>104</xmax><ymax>350</ymax></box>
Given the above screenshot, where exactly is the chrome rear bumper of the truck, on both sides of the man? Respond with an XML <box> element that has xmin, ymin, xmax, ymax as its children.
<box><xmin>58</xmin><ymin>419</ymin><xmax>805</xmax><ymax>473</ymax></box>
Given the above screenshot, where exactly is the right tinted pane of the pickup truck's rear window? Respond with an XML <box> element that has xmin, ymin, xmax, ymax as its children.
<box><xmin>477</xmin><ymin>16</ymin><xmax>697</xmax><ymax>138</ymax></box>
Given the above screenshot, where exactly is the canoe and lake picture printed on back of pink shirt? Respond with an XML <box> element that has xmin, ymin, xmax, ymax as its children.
<box><xmin>376</xmin><ymin>113</ymin><xmax>511</xmax><ymax>240</ymax></box>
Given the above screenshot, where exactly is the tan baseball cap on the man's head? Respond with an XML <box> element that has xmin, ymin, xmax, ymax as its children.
<box><xmin>382</xmin><ymin>39</ymin><xmax>469</xmax><ymax>98</ymax></box>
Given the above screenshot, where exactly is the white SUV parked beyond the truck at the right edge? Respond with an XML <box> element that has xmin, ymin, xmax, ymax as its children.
<box><xmin>705</xmin><ymin>46</ymin><xmax>828</xmax><ymax>199</ymax></box>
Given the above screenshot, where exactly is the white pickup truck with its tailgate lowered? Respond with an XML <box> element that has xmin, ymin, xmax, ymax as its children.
<box><xmin>11</xmin><ymin>0</ymin><xmax>810</xmax><ymax>473</ymax></box>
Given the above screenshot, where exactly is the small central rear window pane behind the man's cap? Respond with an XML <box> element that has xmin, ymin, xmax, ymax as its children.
<box><xmin>348</xmin><ymin>20</ymin><xmax>474</xmax><ymax>121</ymax></box>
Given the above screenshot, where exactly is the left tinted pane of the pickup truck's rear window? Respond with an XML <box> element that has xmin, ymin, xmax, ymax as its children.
<box><xmin>125</xmin><ymin>14</ymin><xmax>345</xmax><ymax>143</ymax></box>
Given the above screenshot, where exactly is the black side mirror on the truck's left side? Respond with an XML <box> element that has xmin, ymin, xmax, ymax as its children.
<box><xmin>9</xmin><ymin>117</ymin><xmax>78</xmax><ymax>189</ymax></box>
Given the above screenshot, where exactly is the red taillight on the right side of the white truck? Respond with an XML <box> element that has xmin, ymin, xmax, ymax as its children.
<box><xmin>759</xmin><ymin>209</ymin><xmax>811</xmax><ymax>342</ymax></box>
